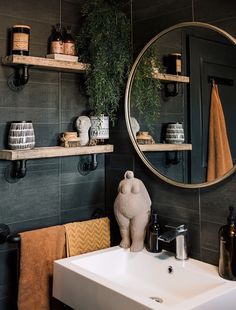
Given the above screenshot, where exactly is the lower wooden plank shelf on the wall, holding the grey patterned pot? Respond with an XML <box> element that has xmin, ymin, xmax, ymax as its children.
<box><xmin>0</xmin><ymin>144</ymin><xmax>114</xmax><ymax>160</ymax></box>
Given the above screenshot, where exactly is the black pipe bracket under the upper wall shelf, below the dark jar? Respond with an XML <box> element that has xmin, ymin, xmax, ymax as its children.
<box><xmin>7</xmin><ymin>65</ymin><xmax>30</xmax><ymax>91</ymax></box>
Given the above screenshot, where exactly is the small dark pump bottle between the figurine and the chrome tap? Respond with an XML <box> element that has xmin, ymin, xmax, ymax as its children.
<box><xmin>146</xmin><ymin>212</ymin><xmax>162</xmax><ymax>253</ymax></box>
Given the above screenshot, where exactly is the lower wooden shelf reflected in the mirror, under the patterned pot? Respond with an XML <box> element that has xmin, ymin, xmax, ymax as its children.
<box><xmin>139</xmin><ymin>143</ymin><xmax>192</xmax><ymax>152</ymax></box>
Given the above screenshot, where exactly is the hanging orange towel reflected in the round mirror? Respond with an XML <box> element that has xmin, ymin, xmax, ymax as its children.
<box><xmin>207</xmin><ymin>82</ymin><xmax>233</xmax><ymax>182</ymax></box>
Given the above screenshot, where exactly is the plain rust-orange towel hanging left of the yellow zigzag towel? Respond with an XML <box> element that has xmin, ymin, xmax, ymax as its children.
<box><xmin>18</xmin><ymin>226</ymin><xmax>65</xmax><ymax>310</ymax></box>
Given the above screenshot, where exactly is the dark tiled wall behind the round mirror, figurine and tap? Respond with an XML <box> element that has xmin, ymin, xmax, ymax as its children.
<box><xmin>106</xmin><ymin>0</ymin><xmax>236</xmax><ymax>264</ymax></box>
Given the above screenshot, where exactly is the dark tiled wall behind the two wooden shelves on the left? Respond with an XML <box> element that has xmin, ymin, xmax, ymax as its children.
<box><xmin>0</xmin><ymin>0</ymin><xmax>105</xmax><ymax>310</ymax></box>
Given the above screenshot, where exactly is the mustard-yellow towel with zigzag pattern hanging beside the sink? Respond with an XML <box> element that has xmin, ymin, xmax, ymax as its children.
<box><xmin>65</xmin><ymin>217</ymin><xmax>110</xmax><ymax>257</ymax></box>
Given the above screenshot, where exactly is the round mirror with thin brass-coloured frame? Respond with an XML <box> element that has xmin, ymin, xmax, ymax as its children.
<box><xmin>125</xmin><ymin>22</ymin><xmax>236</xmax><ymax>188</ymax></box>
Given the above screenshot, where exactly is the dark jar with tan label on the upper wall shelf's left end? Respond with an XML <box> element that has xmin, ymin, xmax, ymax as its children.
<box><xmin>12</xmin><ymin>25</ymin><xmax>30</xmax><ymax>56</ymax></box>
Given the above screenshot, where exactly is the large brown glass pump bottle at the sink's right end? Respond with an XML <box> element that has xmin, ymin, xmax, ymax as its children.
<box><xmin>219</xmin><ymin>206</ymin><xmax>236</xmax><ymax>281</ymax></box>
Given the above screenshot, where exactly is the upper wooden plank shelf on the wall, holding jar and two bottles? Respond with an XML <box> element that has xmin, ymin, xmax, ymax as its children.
<box><xmin>2</xmin><ymin>55</ymin><xmax>89</xmax><ymax>72</ymax></box>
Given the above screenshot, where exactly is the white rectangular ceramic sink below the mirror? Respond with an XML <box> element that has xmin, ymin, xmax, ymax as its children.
<box><xmin>53</xmin><ymin>247</ymin><xmax>236</xmax><ymax>310</ymax></box>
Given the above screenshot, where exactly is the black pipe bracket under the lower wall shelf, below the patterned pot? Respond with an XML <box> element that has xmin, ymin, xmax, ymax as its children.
<box><xmin>4</xmin><ymin>159</ymin><xmax>27</xmax><ymax>183</ymax></box>
